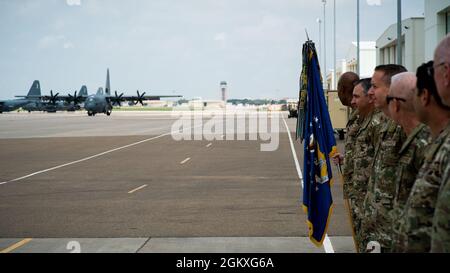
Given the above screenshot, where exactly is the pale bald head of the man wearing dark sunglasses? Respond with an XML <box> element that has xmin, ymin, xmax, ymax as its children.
<box><xmin>389</xmin><ymin>72</ymin><xmax>417</xmax><ymax>112</ymax></box>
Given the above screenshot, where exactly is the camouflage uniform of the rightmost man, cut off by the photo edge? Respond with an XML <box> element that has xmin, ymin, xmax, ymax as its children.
<box><xmin>431</xmin><ymin>125</ymin><xmax>450</xmax><ymax>253</ymax></box>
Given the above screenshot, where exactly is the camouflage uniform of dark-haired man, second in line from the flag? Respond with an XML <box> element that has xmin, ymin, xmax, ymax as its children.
<box><xmin>349</xmin><ymin>108</ymin><xmax>381</xmax><ymax>251</ymax></box>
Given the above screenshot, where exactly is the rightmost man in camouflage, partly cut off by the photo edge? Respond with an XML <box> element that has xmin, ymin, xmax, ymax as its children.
<box><xmin>431</xmin><ymin>34</ymin><xmax>450</xmax><ymax>253</ymax></box>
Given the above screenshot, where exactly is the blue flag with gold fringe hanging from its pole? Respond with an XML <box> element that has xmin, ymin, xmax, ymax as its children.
<box><xmin>296</xmin><ymin>41</ymin><xmax>337</xmax><ymax>247</ymax></box>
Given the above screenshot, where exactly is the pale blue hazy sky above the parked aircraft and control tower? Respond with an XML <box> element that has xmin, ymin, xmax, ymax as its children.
<box><xmin>0</xmin><ymin>0</ymin><xmax>424</xmax><ymax>99</ymax></box>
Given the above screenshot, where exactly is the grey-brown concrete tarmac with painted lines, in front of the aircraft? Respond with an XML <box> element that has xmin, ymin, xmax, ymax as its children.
<box><xmin>0</xmin><ymin>112</ymin><xmax>353</xmax><ymax>252</ymax></box>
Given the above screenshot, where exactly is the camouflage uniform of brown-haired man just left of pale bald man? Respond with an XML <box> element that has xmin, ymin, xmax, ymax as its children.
<box><xmin>361</xmin><ymin>117</ymin><xmax>406</xmax><ymax>252</ymax></box>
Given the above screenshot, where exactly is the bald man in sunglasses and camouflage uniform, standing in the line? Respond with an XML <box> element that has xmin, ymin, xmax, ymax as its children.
<box><xmin>387</xmin><ymin>72</ymin><xmax>430</xmax><ymax>252</ymax></box>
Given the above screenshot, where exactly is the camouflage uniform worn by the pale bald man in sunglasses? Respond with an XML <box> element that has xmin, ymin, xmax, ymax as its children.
<box><xmin>391</xmin><ymin>124</ymin><xmax>431</xmax><ymax>252</ymax></box>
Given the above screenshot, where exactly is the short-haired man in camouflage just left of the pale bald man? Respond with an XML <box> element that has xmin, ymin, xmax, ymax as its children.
<box><xmin>361</xmin><ymin>65</ymin><xmax>406</xmax><ymax>252</ymax></box>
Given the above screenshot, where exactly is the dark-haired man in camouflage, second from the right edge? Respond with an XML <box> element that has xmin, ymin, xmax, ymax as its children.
<box><xmin>395</xmin><ymin>62</ymin><xmax>450</xmax><ymax>252</ymax></box>
